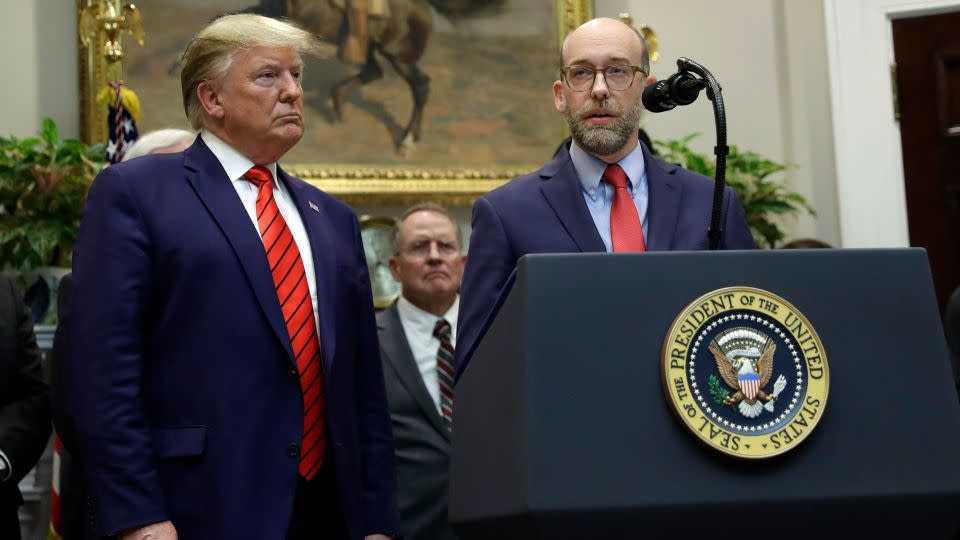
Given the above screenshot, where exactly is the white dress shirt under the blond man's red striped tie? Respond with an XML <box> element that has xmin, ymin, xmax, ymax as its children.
<box><xmin>200</xmin><ymin>129</ymin><xmax>320</xmax><ymax>337</ymax></box>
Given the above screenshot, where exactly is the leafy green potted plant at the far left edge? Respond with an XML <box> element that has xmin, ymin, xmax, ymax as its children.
<box><xmin>0</xmin><ymin>118</ymin><xmax>104</xmax><ymax>324</ymax></box>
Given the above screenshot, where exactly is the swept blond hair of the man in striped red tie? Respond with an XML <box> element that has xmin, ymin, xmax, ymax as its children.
<box><xmin>180</xmin><ymin>13</ymin><xmax>320</xmax><ymax>130</ymax></box>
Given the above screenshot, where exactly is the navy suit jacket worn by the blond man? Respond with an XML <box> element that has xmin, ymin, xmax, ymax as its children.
<box><xmin>62</xmin><ymin>138</ymin><xmax>396</xmax><ymax>540</ymax></box>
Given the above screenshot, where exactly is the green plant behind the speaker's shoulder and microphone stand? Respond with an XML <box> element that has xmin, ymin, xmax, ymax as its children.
<box><xmin>654</xmin><ymin>133</ymin><xmax>816</xmax><ymax>248</ymax></box>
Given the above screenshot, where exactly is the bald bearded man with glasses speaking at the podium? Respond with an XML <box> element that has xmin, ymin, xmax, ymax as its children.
<box><xmin>456</xmin><ymin>19</ymin><xmax>754</xmax><ymax>378</ymax></box>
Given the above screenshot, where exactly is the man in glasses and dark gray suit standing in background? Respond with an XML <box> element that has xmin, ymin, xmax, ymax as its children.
<box><xmin>377</xmin><ymin>203</ymin><xmax>465</xmax><ymax>540</ymax></box>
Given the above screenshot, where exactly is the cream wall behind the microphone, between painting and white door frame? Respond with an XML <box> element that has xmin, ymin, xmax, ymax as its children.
<box><xmin>595</xmin><ymin>0</ymin><xmax>840</xmax><ymax>245</ymax></box>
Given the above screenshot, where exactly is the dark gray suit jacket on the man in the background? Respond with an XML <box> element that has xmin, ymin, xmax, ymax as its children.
<box><xmin>377</xmin><ymin>303</ymin><xmax>456</xmax><ymax>540</ymax></box>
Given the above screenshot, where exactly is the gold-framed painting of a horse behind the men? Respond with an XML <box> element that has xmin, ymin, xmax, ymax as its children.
<box><xmin>77</xmin><ymin>0</ymin><xmax>593</xmax><ymax>205</ymax></box>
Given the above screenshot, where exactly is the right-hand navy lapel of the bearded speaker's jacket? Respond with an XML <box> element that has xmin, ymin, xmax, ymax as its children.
<box><xmin>640</xmin><ymin>143</ymin><xmax>683</xmax><ymax>251</ymax></box>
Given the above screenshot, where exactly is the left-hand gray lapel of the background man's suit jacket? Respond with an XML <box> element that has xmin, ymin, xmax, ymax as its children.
<box><xmin>377</xmin><ymin>302</ymin><xmax>450</xmax><ymax>439</ymax></box>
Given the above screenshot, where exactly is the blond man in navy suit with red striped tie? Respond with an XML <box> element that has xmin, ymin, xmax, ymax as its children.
<box><xmin>62</xmin><ymin>14</ymin><xmax>396</xmax><ymax>540</ymax></box>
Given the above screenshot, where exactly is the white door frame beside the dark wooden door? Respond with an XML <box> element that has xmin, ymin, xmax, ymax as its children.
<box><xmin>824</xmin><ymin>0</ymin><xmax>960</xmax><ymax>247</ymax></box>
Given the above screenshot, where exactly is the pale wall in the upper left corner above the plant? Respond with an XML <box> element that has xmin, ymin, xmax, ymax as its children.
<box><xmin>0</xmin><ymin>0</ymin><xmax>80</xmax><ymax>137</ymax></box>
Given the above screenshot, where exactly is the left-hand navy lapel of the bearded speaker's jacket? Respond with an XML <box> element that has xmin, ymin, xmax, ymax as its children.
<box><xmin>540</xmin><ymin>147</ymin><xmax>606</xmax><ymax>252</ymax></box>
